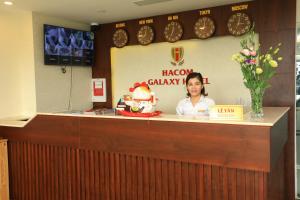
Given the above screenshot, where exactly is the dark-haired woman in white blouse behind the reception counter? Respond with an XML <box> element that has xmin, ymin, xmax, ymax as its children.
<box><xmin>176</xmin><ymin>72</ymin><xmax>215</xmax><ymax>116</ymax></box>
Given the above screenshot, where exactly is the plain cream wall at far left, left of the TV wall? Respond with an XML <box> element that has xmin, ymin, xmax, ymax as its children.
<box><xmin>0</xmin><ymin>8</ymin><xmax>36</xmax><ymax>118</ymax></box>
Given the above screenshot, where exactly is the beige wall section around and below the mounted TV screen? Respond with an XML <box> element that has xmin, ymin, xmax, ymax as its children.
<box><xmin>32</xmin><ymin>12</ymin><xmax>92</xmax><ymax>112</ymax></box>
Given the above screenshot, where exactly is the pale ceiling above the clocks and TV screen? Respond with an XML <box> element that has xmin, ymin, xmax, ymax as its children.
<box><xmin>0</xmin><ymin>0</ymin><xmax>249</xmax><ymax>24</ymax></box>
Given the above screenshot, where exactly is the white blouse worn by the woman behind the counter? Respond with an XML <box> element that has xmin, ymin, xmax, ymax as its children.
<box><xmin>176</xmin><ymin>95</ymin><xmax>215</xmax><ymax>116</ymax></box>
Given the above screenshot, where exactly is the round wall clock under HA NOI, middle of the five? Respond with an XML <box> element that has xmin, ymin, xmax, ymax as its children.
<box><xmin>164</xmin><ymin>21</ymin><xmax>183</xmax><ymax>42</ymax></box>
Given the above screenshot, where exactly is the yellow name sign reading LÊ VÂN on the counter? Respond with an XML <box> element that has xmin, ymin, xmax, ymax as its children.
<box><xmin>209</xmin><ymin>105</ymin><xmax>244</xmax><ymax>120</ymax></box>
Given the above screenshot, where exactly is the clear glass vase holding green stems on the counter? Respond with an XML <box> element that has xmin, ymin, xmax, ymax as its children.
<box><xmin>250</xmin><ymin>88</ymin><xmax>264</xmax><ymax>120</ymax></box>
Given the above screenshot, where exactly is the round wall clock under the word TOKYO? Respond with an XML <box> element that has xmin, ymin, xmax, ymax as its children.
<box><xmin>194</xmin><ymin>17</ymin><xmax>216</xmax><ymax>39</ymax></box>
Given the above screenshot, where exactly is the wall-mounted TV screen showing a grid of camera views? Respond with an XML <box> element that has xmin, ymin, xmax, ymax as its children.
<box><xmin>44</xmin><ymin>24</ymin><xmax>94</xmax><ymax>66</ymax></box>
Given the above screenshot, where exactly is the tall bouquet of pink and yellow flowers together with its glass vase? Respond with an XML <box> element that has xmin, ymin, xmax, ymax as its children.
<box><xmin>232</xmin><ymin>26</ymin><xmax>282</xmax><ymax>118</ymax></box>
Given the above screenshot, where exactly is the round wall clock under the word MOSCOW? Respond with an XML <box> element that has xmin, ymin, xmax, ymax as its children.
<box><xmin>227</xmin><ymin>13</ymin><xmax>251</xmax><ymax>36</ymax></box>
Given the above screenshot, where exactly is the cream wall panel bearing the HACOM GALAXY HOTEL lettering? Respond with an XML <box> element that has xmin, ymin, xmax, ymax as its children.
<box><xmin>111</xmin><ymin>36</ymin><xmax>250</xmax><ymax>113</ymax></box>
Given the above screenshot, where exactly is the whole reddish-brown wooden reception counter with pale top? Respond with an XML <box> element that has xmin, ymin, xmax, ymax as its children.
<box><xmin>0</xmin><ymin>107</ymin><xmax>289</xmax><ymax>200</ymax></box>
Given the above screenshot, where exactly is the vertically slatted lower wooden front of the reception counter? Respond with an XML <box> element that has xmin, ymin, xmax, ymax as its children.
<box><xmin>5</xmin><ymin>142</ymin><xmax>267</xmax><ymax>200</ymax></box>
